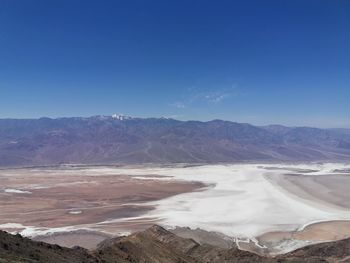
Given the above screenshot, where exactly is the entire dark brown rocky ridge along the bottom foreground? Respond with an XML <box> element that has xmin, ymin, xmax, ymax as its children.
<box><xmin>0</xmin><ymin>225</ymin><xmax>350</xmax><ymax>263</ymax></box>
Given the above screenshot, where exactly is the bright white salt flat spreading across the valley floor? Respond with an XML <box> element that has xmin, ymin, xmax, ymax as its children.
<box><xmin>142</xmin><ymin>164</ymin><xmax>350</xmax><ymax>239</ymax></box>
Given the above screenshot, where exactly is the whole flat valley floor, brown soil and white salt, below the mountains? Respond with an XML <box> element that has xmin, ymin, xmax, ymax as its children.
<box><xmin>0</xmin><ymin>163</ymin><xmax>350</xmax><ymax>254</ymax></box>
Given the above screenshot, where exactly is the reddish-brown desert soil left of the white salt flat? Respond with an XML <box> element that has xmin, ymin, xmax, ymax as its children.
<box><xmin>0</xmin><ymin>169</ymin><xmax>205</xmax><ymax>248</ymax></box>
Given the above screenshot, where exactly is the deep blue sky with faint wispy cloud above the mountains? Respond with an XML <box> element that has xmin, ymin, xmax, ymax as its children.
<box><xmin>0</xmin><ymin>0</ymin><xmax>350</xmax><ymax>127</ymax></box>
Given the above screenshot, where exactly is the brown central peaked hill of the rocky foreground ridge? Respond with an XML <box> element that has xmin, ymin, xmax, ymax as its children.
<box><xmin>98</xmin><ymin>226</ymin><xmax>276</xmax><ymax>263</ymax></box>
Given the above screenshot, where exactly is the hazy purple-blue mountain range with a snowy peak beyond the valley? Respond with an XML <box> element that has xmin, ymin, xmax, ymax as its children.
<box><xmin>0</xmin><ymin>115</ymin><xmax>350</xmax><ymax>166</ymax></box>
